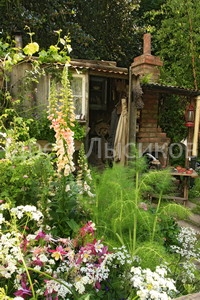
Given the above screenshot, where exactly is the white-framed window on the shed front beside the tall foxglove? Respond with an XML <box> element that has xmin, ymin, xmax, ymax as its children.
<box><xmin>71</xmin><ymin>74</ymin><xmax>85</xmax><ymax>120</ymax></box>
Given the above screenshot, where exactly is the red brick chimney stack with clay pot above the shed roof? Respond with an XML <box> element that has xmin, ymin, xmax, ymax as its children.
<box><xmin>131</xmin><ymin>33</ymin><xmax>163</xmax><ymax>83</ymax></box>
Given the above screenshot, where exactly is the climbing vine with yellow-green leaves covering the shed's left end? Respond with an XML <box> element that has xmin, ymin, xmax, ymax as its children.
<box><xmin>0</xmin><ymin>26</ymin><xmax>71</xmax><ymax>141</ymax></box>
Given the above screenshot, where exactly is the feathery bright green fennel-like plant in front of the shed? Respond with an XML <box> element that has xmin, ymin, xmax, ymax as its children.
<box><xmin>80</xmin><ymin>155</ymin><xmax>188</xmax><ymax>261</ymax></box>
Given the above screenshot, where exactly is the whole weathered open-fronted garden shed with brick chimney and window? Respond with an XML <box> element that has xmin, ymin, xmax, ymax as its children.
<box><xmin>7</xmin><ymin>34</ymin><xmax>200</xmax><ymax>166</ymax></box>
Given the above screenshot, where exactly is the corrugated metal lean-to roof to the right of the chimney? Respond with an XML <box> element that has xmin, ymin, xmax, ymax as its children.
<box><xmin>141</xmin><ymin>83</ymin><xmax>200</xmax><ymax>97</ymax></box>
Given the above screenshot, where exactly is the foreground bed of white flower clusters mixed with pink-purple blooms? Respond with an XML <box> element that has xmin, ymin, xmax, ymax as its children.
<box><xmin>0</xmin><ymin>203</ymin><xmax>179</xmax><ymax>300</ymax></box>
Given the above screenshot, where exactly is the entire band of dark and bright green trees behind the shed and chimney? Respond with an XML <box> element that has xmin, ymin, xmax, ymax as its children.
<box><xmin>0</xmin><ymin>0</ymin><xmax>200</xmax><ymax>89</ymax></box>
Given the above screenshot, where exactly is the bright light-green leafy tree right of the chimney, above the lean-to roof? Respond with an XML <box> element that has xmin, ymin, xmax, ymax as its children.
<box><xmin>149</xmin><ymin>0</ymin><xmax>200</xmax><ymax>90</ymax></box>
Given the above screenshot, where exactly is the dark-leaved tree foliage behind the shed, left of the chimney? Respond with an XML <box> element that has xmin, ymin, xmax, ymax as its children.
<box><xmin>0</xmin><ymin>0</ymin><xmax>141</xmax><ymax>66</ymax></box>
